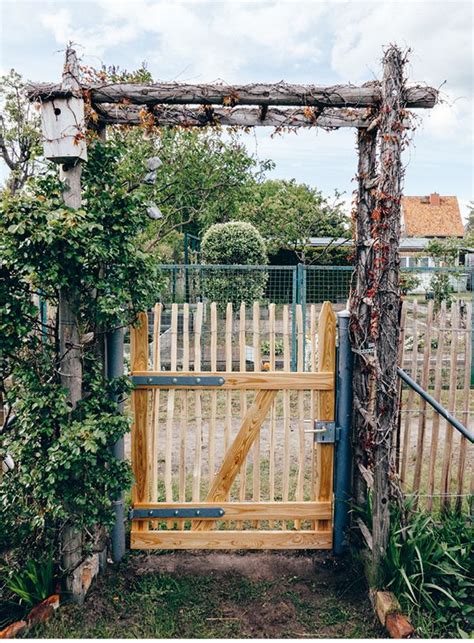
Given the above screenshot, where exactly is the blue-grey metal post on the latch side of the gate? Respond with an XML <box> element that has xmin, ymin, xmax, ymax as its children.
<box><xmin>333</xmin><ymin>310</ymin><xmax>353</xmax><ymax>556</ymax></box>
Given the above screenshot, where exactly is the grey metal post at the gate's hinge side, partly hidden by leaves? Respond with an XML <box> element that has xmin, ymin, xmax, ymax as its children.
<box><xmin>106</xmin><ymin>328</ymin><xmax>125</xmax><ymax>563</ymax></box>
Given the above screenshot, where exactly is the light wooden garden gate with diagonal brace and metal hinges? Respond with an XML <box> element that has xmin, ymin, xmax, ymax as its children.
<box><xmin>130</xmin><ymin>302</ymin><xmax>336</xmax><ymax>549</ymax></box>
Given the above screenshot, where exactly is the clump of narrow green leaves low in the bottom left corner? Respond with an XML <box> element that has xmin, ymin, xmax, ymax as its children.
<box><xmin>5</xmin><ymin>556</ymin><xmax>55</xmax><ymax>608</ymax></box>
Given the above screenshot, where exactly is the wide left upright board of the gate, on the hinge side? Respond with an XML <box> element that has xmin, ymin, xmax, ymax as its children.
<box><xmin>130</xmin><ymin>313</ymin><xmax>150</xmax><ymax>530</ymax></box>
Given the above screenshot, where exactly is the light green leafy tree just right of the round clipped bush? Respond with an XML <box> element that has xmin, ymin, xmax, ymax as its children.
<box><xmin>239</xmin><ymin>179</ymin><xmax>350</xmax><ymax>263</ymax></box>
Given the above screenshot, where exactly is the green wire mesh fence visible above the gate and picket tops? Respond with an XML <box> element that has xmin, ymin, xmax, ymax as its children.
<box><xmin>159</xmin><ymin>264</ymin><xmax>474</xmax><ymax>306</ymax></box>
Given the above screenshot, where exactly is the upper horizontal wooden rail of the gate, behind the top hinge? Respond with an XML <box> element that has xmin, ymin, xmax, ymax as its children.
<box><xmin>132</xmin><ymin>370</ymin><xmax>334</xmax><ymax>396</ymax></box>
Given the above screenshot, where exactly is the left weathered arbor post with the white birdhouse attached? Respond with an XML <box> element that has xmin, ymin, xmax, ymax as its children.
<box><xmin>41</xmin><ymin>47</ymin><xmax>87</xmax><ymax>595</ymax></box>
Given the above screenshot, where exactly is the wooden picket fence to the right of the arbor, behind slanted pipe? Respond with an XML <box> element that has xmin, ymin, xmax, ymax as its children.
<box><xmin>397</xmin><ymin>300</ymin><xmax>474</xmax><ymax>510</ymax></box>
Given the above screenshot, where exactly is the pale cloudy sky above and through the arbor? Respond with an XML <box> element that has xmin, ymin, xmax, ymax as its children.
<box><xmin>0</xmin><ymin>0</ymin><xmax>474</xmax><ymax>216</ymax></box>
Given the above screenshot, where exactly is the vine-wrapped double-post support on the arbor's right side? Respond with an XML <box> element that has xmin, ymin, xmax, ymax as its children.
<box><xmin>351</xmin><ymin>46</ymin><xmax>405</xmax><ymax>584</ymax></box>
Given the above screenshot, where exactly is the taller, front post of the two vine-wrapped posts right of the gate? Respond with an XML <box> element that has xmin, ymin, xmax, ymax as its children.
<box><xmin>372</xmin><ymin>47</ymin><xmax>405</xmax><ymax>577</ymax></box>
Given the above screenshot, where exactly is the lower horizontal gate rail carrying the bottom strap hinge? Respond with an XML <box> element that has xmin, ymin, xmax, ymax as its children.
<box><xmin>134</xmin><ymin>501</ymin><xmax>332</xmax><ymax>521</ymax></box>
